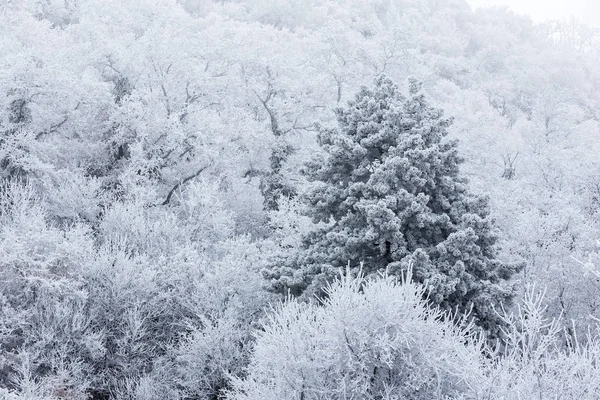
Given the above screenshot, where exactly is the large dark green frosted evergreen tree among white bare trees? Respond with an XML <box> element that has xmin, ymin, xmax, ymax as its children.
<box><xmin>266</xmin><ymin>76</ymin><xmax>522</xmax><ymax>333</ymax></box>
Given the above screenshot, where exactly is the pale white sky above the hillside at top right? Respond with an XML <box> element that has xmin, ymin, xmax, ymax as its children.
<box><xmin>468</xmin><ymin>0</ymin><xmax>600</xmax><ymax>26</ymax></box>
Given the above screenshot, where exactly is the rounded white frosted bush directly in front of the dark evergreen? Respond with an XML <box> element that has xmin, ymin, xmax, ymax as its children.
<box><xmin>228</xmin><ymin>268</ymin><xmax>486</xmax><ymax>400</ymax></box>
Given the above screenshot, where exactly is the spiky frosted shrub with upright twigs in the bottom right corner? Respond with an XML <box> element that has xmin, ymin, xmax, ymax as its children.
<box><xmin>483</xmin><ymin>288</ymin><xmax>600</xmax><ymax>400</ymax></box>
